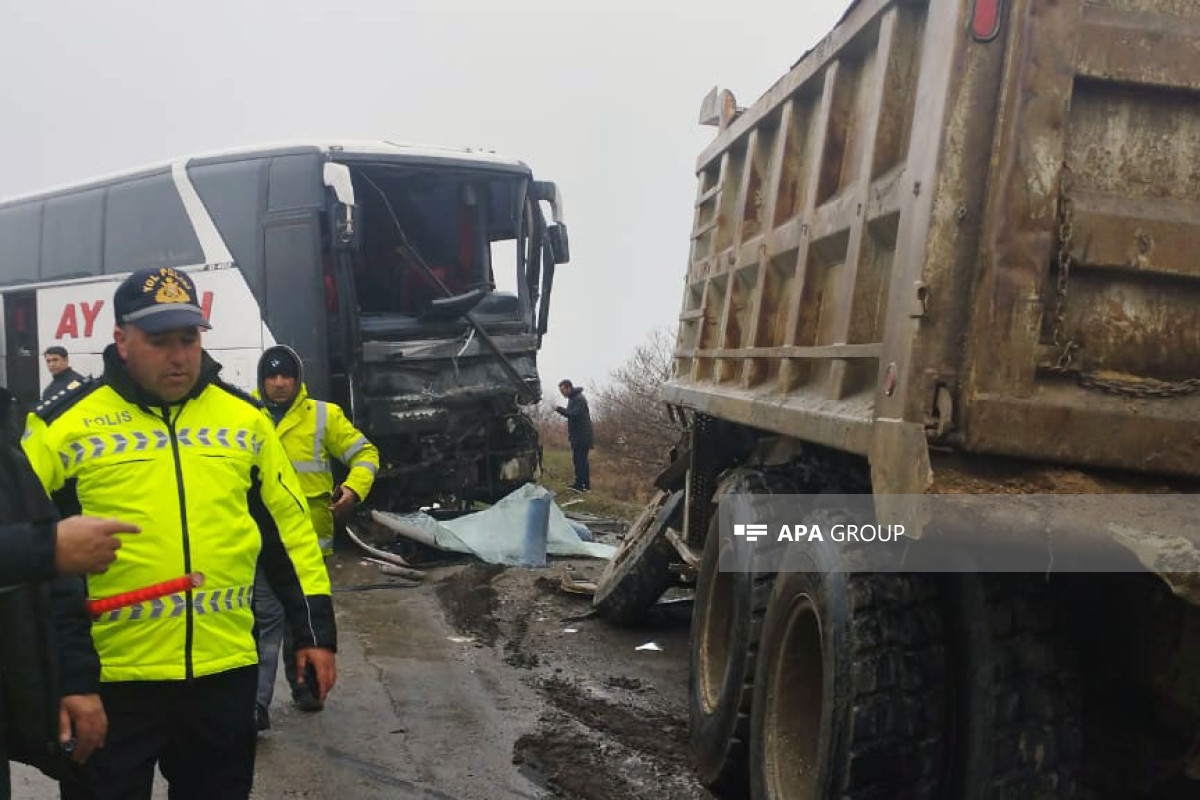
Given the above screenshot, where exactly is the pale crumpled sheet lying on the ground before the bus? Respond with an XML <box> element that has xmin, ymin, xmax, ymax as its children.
<box><xmin>372</xmin><ymin>483</ymin><xmax>617</xmax><ymax>566</ymax></box>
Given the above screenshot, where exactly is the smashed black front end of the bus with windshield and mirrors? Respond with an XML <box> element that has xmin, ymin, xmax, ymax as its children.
<box><xmin>324</xmin><ymin>155</ymin><xmax>569</xmax><ymax>507</ymax></box>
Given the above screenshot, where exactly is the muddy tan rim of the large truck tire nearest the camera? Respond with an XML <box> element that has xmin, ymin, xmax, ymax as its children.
<box><xmin>763</xmin><ymin>595</ymin><xmax>824</xmax><ymax>800</ymax></box>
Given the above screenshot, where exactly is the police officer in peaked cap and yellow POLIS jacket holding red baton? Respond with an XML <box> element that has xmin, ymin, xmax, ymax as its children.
<box><xmin>24</xmin><ymin>267</ymin><xmax>336</xmax><ymax>800</ymax></box>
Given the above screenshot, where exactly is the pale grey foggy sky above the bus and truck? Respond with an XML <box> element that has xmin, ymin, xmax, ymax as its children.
<box><xmin>0</xmin><ymin>0</ymin><xmax>848</xmax><ymax>396</ymax></box>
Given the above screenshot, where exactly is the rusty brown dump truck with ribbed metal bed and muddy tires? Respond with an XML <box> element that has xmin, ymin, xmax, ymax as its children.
<box><xmin>594</xmin><ymin>0</ymin><xmax>1200</xmax><ymax>799</ymax></box>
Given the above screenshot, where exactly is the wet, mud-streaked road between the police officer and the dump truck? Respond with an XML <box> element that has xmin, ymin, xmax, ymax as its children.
<box><xmin>13</xmin><ymin>558</ymin><xmax>710</xmax><ymax>800</ymax></box>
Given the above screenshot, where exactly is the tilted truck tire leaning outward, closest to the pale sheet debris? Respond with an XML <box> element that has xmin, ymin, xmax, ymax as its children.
<box><xmin>592</xmin><ymin>491</ymin><xmax>683</xmax><ymax>625</ymax></box>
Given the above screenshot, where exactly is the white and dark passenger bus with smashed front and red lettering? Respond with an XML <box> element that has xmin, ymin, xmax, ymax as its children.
<box><xmin>0</xmin><ymin>143</ymin><xmax>569</xmax><ymax>510</ymax></box>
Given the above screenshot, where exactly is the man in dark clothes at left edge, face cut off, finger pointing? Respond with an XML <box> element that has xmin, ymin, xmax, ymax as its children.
<box><xmin>0</xmin><ymin>389</ymin><xmax>137</xmax><ymax>799</ymax></box>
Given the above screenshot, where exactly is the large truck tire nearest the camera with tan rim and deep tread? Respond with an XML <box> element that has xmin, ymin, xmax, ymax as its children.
<box><xmin>750</xmin><ymin>512</ymin><xmax>949</xmax><ymax>800</ymax></box>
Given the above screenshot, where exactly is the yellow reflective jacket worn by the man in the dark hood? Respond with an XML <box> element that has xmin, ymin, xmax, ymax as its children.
<box><xmin>256</xmin><ymin>384</ymin><xmax>379</xmax><ymax>500</ymax></box>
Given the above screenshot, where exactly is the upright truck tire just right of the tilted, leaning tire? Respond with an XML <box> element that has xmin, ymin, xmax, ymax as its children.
<box><xmin>688</xmin><ymin>470</ymin><xmax>796</xmax><ymax>795</ymax></box>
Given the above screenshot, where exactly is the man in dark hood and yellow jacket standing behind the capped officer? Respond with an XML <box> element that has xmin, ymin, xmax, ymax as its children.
<box><xmin>254</xmin><ymin>345</ymin><xmax>379</xmax><ymax>730</ymax></box>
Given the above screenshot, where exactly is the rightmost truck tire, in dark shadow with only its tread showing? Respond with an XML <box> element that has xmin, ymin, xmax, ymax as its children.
<box><xmin>950</xmin><ymin>573</ymin><xmax>1082</xmax><ymax>800</ymax></box>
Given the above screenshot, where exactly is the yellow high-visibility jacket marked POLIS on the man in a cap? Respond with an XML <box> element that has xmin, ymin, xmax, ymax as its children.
<box><xmin>23</xmin><ymin>347</ymin><xmax>337</xmax><ymax>681</ymax></box>
